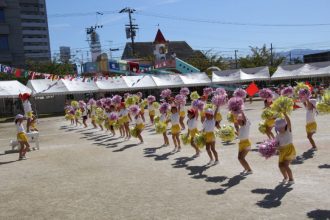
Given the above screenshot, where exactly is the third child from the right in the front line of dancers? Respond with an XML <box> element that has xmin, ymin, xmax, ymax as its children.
<box><xmin>203</xmin><ymin>107</ymin><xmax>219</xmax><ymax>165</ymax></box>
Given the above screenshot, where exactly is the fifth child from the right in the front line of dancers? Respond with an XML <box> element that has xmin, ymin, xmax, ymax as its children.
<box><xmin>167</xmin><ymin>105</ymin><xmax>181</xmax><ymax>153</ymax></box>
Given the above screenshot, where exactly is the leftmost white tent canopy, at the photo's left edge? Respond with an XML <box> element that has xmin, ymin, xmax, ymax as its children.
<box><xmin>0</xmin><ymin>80</ymin><xmax>31</xmax><ymax>98</ymax></box>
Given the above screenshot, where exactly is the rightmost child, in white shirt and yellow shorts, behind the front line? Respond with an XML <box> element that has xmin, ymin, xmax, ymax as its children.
<box><xmin>304</xmin><ymin>99</ymin><xmax>317</xmax><ymax>150</ymax></box>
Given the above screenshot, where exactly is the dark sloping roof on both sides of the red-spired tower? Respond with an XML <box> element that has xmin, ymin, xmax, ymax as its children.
<box><xmin>121</xmin><ymin>41</ymin><xmax>200</xmax><ymax>61</ymax></box>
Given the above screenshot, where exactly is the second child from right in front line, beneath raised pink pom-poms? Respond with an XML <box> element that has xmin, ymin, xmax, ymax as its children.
<box><xmin>237</xmin><ymin>112</ymin><xmax>252</xmax><ymax>175</ymax></box>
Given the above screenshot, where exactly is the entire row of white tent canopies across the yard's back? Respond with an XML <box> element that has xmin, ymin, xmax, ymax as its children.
<box><xmin>0</xmin><ymin>62</ymin><xmax>330</xmax><ymax>98</ymax></box>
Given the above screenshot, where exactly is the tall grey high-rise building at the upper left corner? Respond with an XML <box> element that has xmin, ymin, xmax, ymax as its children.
<box><xmin>0</xmin><ymin>0</ymin><xmax>51</xmax><ymax>68</ymax></box>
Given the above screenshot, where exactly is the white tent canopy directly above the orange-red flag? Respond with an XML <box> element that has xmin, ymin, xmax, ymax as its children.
<box><xmin>240</xmin><ymin>66</ymin><xmax>270</xmax><ymax>82</ymax></box>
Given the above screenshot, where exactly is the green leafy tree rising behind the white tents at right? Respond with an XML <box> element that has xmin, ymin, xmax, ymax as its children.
<box><xmin>239</xmin><ymin>45</ymin><xmax>285</xmax><ymax>74</ymax></box>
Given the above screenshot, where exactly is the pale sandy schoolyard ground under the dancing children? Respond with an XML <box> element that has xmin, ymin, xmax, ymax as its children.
<box><xmin>0</xmin><ymin>102</ymin><xmax>330</xmax><ymax>220</ymax></box>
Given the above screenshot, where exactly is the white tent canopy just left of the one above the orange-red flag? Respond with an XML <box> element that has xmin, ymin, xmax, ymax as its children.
<box><xmin>212</xmin><ymin>69</ymin><xmax>241</xmax><ymax>84</ymax></box>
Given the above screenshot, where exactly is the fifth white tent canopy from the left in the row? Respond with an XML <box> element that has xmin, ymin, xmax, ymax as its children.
<box><xmin>123</xmin><ymin>75</ymin><xmax>157</xmax><ymax>89</ymax></box>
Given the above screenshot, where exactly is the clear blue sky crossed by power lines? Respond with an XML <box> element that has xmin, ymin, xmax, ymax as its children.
<box><xmin>46</xmin><ymin>0</ymin><xmax>330</xmax><ymax>59</ymax></box>
